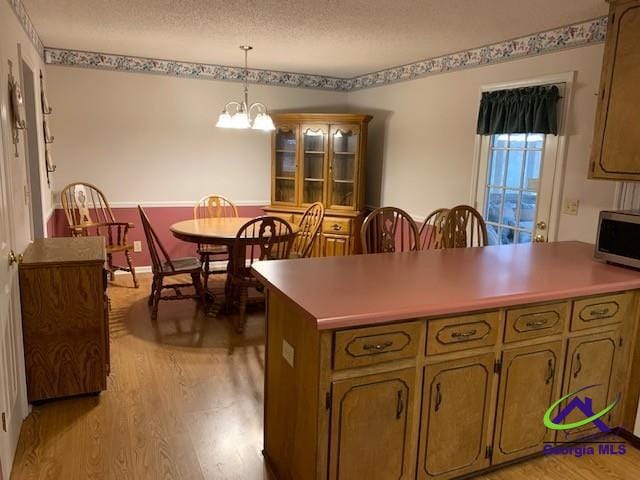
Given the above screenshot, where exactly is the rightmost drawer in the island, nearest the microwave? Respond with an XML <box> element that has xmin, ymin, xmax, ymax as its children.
<box><xmin>571</xmin><ymin>293</ymin><xmax>632</xmax><ymax>331</ymax></box>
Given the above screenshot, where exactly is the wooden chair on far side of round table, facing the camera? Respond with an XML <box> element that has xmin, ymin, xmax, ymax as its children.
<box><xmin>193</xmin><ymin>195</ymin><xmax>238</xmax><ymax>290</ymax></box>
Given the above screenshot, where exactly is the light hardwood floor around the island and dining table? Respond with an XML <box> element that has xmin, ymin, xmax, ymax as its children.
<box><xmin>11</xmin><ymin>276</ymin><xmax>640</xmax><ymax>480</ymax></box>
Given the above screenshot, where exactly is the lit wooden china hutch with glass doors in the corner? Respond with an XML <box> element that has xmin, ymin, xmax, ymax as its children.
<box><xmin>264</xmin><ymin>113</ymin><xmax>371</xmax><ymax>256</ymax></box>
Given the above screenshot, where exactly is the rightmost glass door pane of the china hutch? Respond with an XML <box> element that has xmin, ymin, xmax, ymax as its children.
<box><xmin>331</xmin><ymin>128</ymin><xmax>360</xmax><ymax>206</ymax></box>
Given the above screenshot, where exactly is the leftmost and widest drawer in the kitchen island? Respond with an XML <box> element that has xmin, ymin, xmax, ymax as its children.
<box><xmin>333</xmin><ymin>322</ymin><xmax>421</xmax><ymax>370</ymax></box>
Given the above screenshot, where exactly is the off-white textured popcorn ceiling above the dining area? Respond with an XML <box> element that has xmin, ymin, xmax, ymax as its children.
<box><xmin>23</xmin><ymin>0</ymin><xmax>607</xmax><ymax>77</ymax></box>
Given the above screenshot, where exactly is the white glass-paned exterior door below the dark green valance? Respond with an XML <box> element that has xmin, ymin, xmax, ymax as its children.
<box><xmin>476</xmin><ymin>84</ymin><xmax>565</xmax><ymax>245</ymax></box>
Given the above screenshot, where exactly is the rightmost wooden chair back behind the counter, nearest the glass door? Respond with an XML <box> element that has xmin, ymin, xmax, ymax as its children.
<box><xmin>443</xmin><ymin>205</ymin><xmax>489</xmax><ymax>248</ymax></box>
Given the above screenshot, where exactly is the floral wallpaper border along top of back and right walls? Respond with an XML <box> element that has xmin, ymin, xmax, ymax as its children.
<box><xmin>33</xmin><ymin>12</ymin><xmax>608</xmax><ymax>91</ymax></box>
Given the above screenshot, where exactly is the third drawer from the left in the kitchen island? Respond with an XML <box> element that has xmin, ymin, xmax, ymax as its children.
<box><xmin>504</xmin><ymin>302</ymin><xmax>569</xmax><ymax>343</ymax></box>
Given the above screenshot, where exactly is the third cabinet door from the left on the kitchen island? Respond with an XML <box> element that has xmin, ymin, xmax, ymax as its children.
<box><xmin>493</xmin><ymin>341</ymin><xmax>563</xmax><ymax>464</ymax></box>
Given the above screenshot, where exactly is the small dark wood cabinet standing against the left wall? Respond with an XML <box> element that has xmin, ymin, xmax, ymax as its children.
<box><xmin>19</xmin><ymin>237</ymin><xmax>109</xmax><ymax>402</ymax></box>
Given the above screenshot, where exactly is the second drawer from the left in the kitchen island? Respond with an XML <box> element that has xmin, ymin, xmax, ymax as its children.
<box><xmin>427</xmin><ymin>311</ymin><xmax>499</xmax><ymax>355</ymax></box>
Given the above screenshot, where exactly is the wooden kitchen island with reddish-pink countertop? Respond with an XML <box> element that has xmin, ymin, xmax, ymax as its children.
<box><xmin>254</xmin><ymin>242</ymin><xmax>640</xmax><ymax>480</ymax></box>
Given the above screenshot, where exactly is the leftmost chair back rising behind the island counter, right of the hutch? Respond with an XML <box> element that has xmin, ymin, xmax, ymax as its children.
<box><xmin>360</xmin><ymin>207</ymin><xmax>420</xmax><ymax>253</ymax></box>
